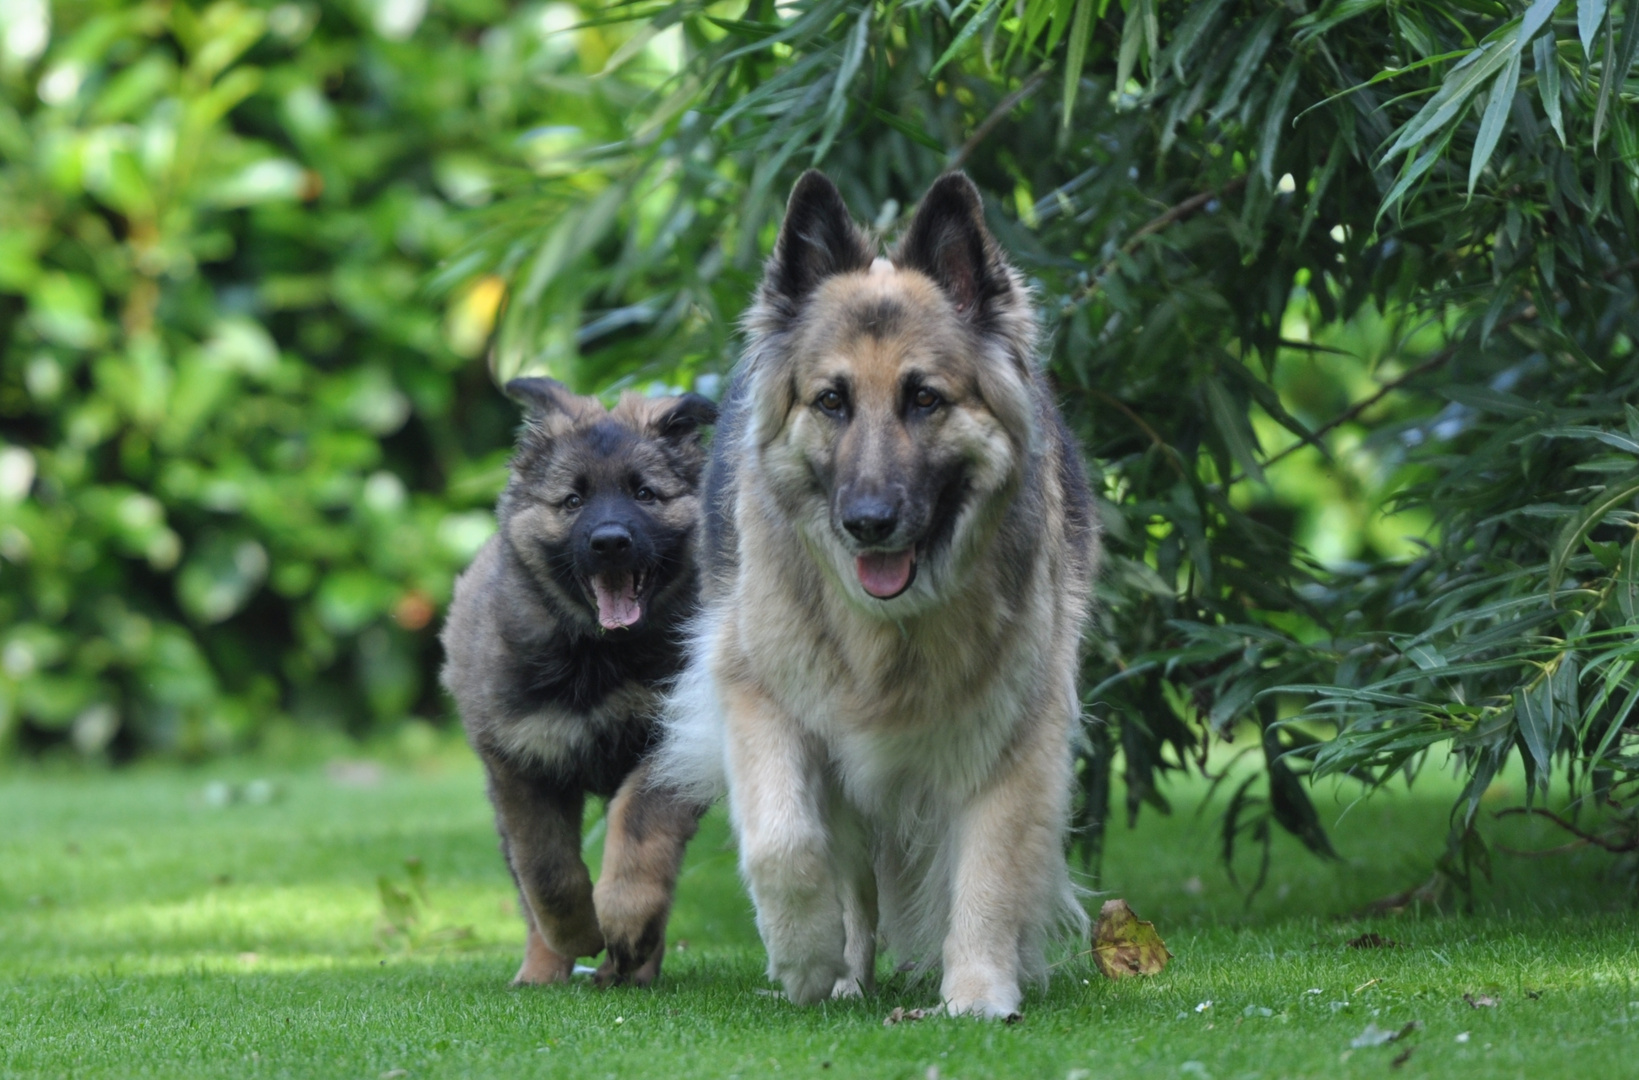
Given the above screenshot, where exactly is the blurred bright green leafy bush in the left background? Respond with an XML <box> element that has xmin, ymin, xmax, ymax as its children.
<box><xmin>0</xmin><ymin>0</ymin><xmax>671</xmax><ymax>756</ymax></box>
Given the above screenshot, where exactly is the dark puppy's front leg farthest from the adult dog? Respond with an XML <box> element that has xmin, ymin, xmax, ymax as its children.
<box><xmin>484</xmin><ymin>754</ymin><xmax>603</xmax><ymax>985</ymax></box>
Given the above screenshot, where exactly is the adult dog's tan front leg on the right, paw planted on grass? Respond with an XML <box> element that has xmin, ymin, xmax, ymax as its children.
<box><xmin>939</xmin><ymin>713</ymin><xmax>1070</xmax><ymax>1019</ymax></box>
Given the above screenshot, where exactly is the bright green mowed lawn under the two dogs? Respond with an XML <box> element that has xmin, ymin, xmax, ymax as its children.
<box><xmin>0</xmin><ymin>752</ymin><xmax>1639</xmax><ymax>1080</ymax></box>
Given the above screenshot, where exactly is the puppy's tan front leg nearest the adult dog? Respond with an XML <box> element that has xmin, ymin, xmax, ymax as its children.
<box><xmin>592</xmin><ymin>762</ymin><xmax>705</xmax><ymax>987</ymax></box>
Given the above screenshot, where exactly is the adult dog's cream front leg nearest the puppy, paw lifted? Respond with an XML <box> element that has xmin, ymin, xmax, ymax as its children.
<box><xmin>723</xmin><ymin>682</ymin><xmax>847</xmax><ymax>1005</ymax></box>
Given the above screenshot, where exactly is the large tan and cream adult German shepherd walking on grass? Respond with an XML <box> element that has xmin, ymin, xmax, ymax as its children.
<box><xmin>661</xmin><ymin>172</ymin><xmax>1098</xmax><ymax>1018</ymax></box>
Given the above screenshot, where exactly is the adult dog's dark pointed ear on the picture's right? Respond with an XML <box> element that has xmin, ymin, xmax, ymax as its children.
<box><xmin>893</xmin><ymin>172</ymin><xmax>1011</xmax><ymax>320</ymax></box>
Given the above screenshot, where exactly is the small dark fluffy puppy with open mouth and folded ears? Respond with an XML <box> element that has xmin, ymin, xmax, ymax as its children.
<box><xmin>443</xmin><ymin>379</ymin><xmax>716</xmax><ymax>985</ymax></box>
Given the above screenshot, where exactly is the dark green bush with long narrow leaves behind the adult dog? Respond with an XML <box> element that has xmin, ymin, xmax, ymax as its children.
<box><xmin>455</xmin><ymin>0</ymin><xmax>1639</xmax><ymax>875</ymax></box>
